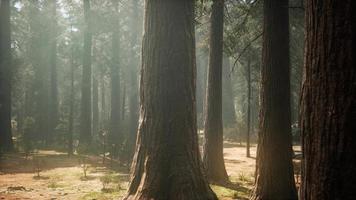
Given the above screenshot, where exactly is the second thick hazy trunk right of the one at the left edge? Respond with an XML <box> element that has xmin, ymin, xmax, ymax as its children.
<box><xmin>79</xmin><ymin>0</ymin><xmax>92</xmax><ymax>144</ymax></box>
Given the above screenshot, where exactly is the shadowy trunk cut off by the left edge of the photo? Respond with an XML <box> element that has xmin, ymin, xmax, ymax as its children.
<box><xmin>0</xmin><ymin>0</ymin><xmax>13</xmax><ymax>152</ymax></box>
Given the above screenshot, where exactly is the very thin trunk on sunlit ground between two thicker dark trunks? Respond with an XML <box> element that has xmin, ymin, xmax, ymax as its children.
<box><xmin>246</xmin><ymin>57</ymin><xmax>251</xmax><ymax>157</ymax></box>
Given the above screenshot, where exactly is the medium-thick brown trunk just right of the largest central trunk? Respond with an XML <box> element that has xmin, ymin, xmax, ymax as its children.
<box><xmin>203</xmin><ymin>0</ymin><xmax>228</xmax><ymax>182</ymax></box>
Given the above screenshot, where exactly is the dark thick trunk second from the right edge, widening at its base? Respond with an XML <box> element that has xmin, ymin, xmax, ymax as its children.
<box><xmin>252</xmin><ymin>0</ymin><xmax>297</xmax><ymax>199</ymax></box>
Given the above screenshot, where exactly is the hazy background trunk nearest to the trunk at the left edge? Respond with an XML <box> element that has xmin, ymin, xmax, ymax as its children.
<box><xmin>47</xmin><ymin>0</ymin><xmax>59</xmax><ymax>143</ymax></box>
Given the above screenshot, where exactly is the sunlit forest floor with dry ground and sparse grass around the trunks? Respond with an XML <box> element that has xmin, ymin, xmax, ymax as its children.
<box><xmin>0</xmin><ymin>142</ymin><xmax>298</xmax><ymax>200</ymax></box>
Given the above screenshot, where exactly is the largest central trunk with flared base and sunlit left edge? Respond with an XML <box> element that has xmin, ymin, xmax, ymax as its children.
<box><xmin>126</xmin><ymin>0</ymin><xmax>216</xmax><ymax>200</ymax></box>
